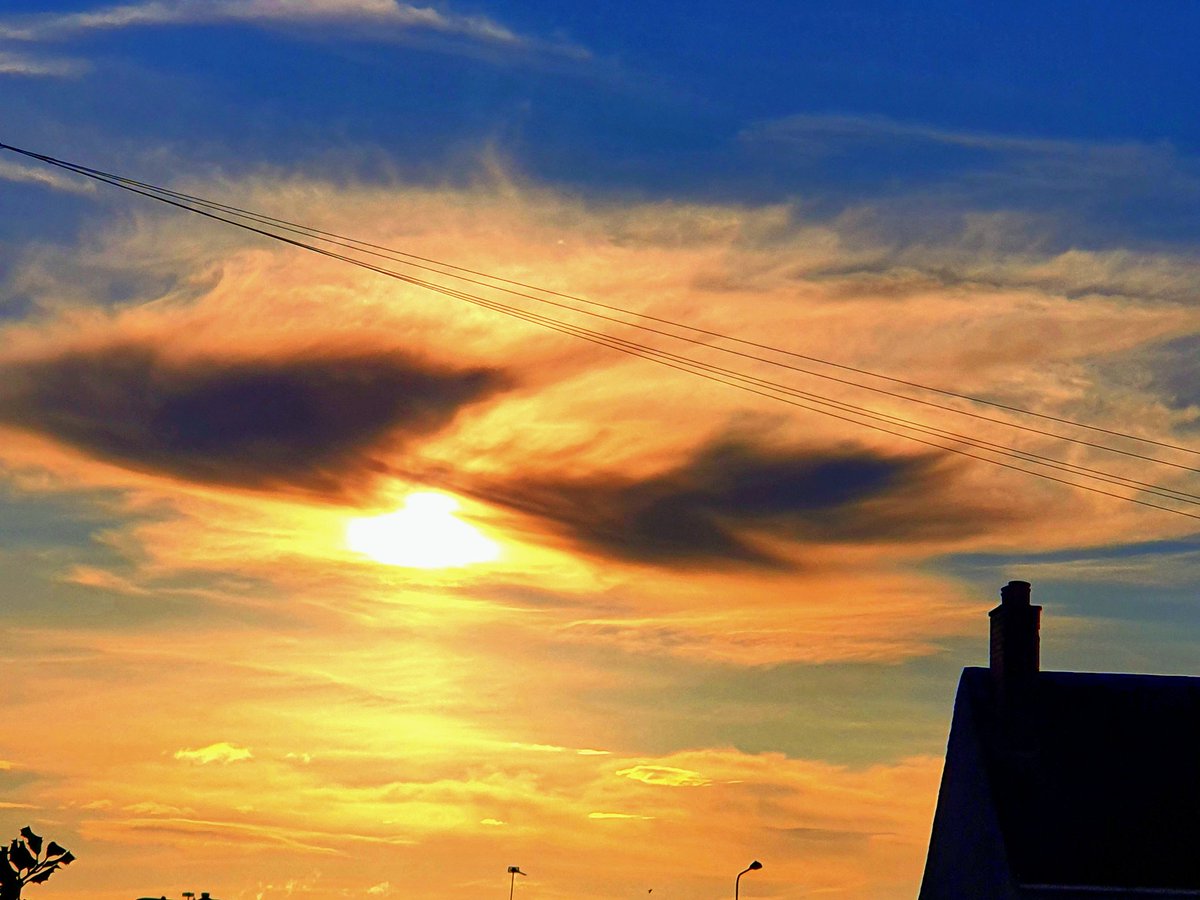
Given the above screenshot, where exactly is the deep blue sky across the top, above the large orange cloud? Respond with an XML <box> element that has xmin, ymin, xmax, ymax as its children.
<box><xmin>5</xmin><ymin>2</ymin><xmax>1200</xmax><ymax>210</ymax></box>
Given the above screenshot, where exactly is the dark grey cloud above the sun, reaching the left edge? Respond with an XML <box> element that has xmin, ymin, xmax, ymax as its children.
<box><xmin>0</xmin><ymin>343</ymin><xmax>505</xmax><ymax>494</ymax></box>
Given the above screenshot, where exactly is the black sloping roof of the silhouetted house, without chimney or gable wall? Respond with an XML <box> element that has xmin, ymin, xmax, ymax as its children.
<box><xmin>960</xmin><ymin>668</ymin><xmax>1200</xmax><ymax>895</ymax></box>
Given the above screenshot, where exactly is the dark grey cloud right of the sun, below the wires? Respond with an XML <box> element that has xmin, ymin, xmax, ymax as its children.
<box><xmin>468</xmin><ymin>440</ymin><xmax>982</xmax><ymax>568</ymax></box>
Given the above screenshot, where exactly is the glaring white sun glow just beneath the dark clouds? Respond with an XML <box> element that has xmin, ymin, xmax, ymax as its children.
<box><xmin>346</xmin><ymin>492</ymin><xmax>500</xmax><ymax>569</ymax></box>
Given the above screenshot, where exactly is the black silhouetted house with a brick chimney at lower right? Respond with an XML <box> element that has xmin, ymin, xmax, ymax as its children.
<box><xmin>919</xmin><ymin>581</ymin><xmax>1200</xmax><ymax>900</ymax></box>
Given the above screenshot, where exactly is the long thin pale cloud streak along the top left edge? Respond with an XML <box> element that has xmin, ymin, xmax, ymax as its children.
<box><xmin>0</xmin><ymin>0</ymin><xmax>587</xmax><ymax>58</ymax></box>
